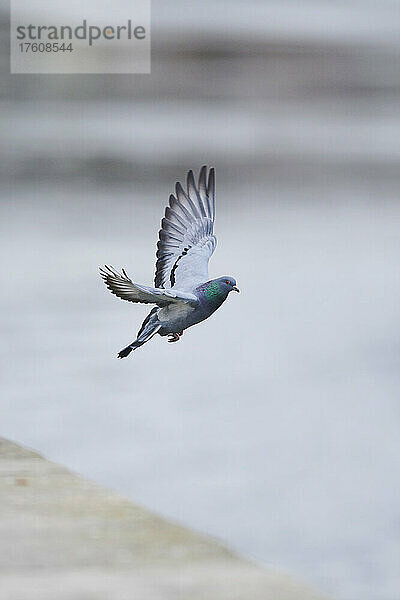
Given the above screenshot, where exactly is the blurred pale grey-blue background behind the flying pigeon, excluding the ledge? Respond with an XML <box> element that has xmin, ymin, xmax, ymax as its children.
<box><xmin>0</xmin><ymin>0</ymin><xmax>400</xmax><ymax>600</ymax></box>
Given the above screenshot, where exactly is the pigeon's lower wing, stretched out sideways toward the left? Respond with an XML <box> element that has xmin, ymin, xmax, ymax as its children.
<box><xmin>100</xmin><ymin>265</ymin><xmax>198</xmax><ymax>306</ymax></box>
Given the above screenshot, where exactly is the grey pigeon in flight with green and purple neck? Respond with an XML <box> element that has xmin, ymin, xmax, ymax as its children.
<box><xmin>100</xmin><ymin>166</ymin><xmax>239</xmax><ymax>358</ymax></box>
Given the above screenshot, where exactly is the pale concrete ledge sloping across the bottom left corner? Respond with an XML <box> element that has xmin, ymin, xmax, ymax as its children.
<box><xmin>0</xmin><ymin>438</ymin><xmax>323</xmax><ymax>600</ymax></box>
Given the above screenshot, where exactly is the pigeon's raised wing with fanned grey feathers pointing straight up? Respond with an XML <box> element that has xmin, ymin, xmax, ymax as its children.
<box><xmin>154</xmin><ymin>167</ymin><xmax>217</xmax><ymax>290</ymax></box>
